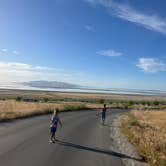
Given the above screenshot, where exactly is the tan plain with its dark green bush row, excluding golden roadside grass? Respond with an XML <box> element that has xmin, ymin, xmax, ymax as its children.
<box><xmin>0</xmin><ymin>89</ymin><xmax>166</xmax><ymax>108</ymax></box>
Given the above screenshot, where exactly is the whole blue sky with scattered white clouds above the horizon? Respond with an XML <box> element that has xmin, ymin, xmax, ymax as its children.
<box><xmin>0</xmin><ymin>0</ymin><xmax>166</xmax><ymax>90</ymax></box>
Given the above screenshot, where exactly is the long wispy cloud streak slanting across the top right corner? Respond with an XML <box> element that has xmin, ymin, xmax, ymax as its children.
<box><xmin>85</xmin><ymin>0</ymin><xmax>166</xmax><ymax>34</ymax></box>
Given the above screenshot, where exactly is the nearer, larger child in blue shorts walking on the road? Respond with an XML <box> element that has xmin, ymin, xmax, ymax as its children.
<box><xmin>50</xmin><ymin>109</ymin><xmax>62</xmax><ymax>143</ymax></box>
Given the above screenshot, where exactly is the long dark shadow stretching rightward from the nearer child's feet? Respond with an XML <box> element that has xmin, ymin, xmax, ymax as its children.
<box><xmin>56</xmin><ymin>140</ymin><xmax>142</xmax><ymax>161</ymax></box>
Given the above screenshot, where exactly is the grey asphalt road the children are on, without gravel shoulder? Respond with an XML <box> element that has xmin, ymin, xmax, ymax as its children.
<box><xmin>0</xmin><ymin>111</ymin><xmax>124</xmax><ymax>166</ymax></box>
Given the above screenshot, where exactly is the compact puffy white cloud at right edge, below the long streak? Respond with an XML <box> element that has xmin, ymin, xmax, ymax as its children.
<box><xmin>137</xmin><ymin>58</ymin><xmax>166</xmax><ymax>73</ymax></box>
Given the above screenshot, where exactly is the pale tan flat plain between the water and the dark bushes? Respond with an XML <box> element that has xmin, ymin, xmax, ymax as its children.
<box><xmin>0</xmin><ymin>89</ymin><xmax>166</xmax><ymax>101</ymax></box>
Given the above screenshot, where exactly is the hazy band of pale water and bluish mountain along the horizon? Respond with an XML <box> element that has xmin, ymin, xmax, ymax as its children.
<box><xmin>0</xmin><ymin>80</ymin><xmax>166</xmax><ymax>96</ymax></box>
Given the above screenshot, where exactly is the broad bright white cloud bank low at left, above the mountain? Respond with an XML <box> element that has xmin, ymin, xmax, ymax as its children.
<box><xmin>0</xmin><ymin>61</ymin><xmax>85</xmax><ymax>84</ymax></box>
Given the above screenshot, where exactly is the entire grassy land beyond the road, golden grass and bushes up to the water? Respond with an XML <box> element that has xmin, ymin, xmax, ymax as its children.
<box><xmin>0</xmin><ymin>89</ymin><xmax>166</xmax><ymax>121</ymax></box>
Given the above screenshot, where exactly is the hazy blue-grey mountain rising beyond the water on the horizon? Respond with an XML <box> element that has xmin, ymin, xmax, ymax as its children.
<box><xmin>23</xmin><ymin>80</ymin><xmax>81</xmax><ymax>89</ymax></box>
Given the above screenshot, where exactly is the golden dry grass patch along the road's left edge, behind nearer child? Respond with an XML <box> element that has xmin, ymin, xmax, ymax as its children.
<box><xmin>0</xmin><ymin>100</ymin><xmax>86</xmax><ymax>121</ymax></box>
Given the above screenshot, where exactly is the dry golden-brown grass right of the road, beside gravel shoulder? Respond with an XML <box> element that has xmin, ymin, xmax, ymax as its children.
<box><xmin>122</xmin><ymin>110</ymin><xmax>166</xmax><ymax>166</ymax></box>
